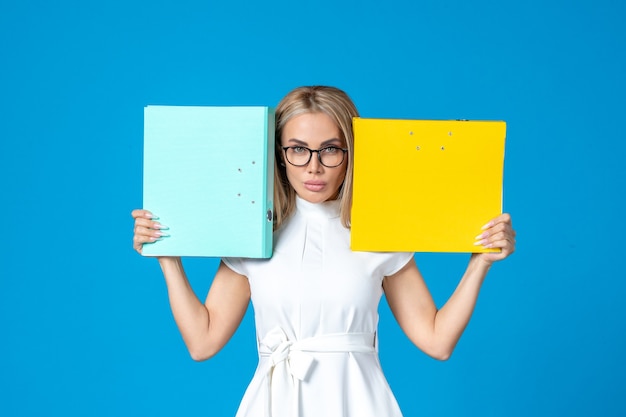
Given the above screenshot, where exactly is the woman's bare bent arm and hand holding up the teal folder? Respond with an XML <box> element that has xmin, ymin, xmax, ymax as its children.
<box><xmin>133</xmin><ymin>210</ymin><xmax>250</xmax><ymax>361</ymax></box>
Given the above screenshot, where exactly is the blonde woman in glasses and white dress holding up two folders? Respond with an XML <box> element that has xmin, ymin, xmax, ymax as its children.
<box><xmin>133</xmin><ymin>87</ymin><xmax>515</xmax><ymax>417</ymax></box>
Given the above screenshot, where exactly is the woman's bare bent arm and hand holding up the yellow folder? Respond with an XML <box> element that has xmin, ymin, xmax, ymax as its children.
<box><xmin>383</xmin><ymin>214</ymin><xmax>515</xmax><ymax>360</ymax></box>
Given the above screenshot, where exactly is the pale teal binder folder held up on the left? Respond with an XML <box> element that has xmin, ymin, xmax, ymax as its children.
<box><xmin>143</xmin><ymin>106</ymin><xmax>274</xmax><ymax>258</ymax></box>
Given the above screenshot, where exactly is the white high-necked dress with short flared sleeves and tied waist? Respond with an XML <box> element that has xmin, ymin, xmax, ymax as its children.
<box><xmin>224</xmin><ymin>198</ymin><xmax>413</xmax><ymax>417</ymax></box>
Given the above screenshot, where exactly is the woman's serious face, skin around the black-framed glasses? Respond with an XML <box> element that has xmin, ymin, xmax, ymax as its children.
<box><xmin>281</xmin><ymin>113</ymin><xmax>348</xmax><ymax>203</ymax></box>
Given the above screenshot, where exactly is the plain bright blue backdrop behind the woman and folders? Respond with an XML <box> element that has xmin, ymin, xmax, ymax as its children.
<box><xmin>0</xmin><ymin>0</ymin><xmax>626</xmax><ymax>417</ymax></box>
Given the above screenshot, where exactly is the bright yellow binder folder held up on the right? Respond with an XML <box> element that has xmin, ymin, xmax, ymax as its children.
<box><xmin>351</xmin><ymin>118</ymin><xmax>506</xmax><ymax>252</ymax></box>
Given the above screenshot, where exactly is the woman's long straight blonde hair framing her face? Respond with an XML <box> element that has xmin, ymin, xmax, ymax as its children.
<box><xmin>274</xmin><ymin>86</ymin><xmax>359</xmax><ymax>230</ymax></box>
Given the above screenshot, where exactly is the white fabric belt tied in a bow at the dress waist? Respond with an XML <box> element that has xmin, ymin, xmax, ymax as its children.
<box><xmin>259</xmin><ymin>327</ymin><xmax>376</xmax><ymax>417</ymax></box>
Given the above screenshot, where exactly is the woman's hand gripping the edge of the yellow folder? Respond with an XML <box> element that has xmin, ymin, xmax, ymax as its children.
<box><xmin>474</xmin><ymin>213</ymin><xmax>515</xmax><ymax>264</ymax></box>
